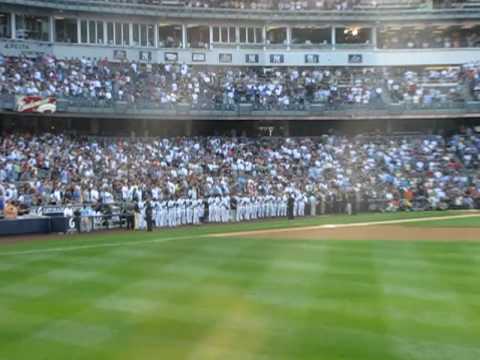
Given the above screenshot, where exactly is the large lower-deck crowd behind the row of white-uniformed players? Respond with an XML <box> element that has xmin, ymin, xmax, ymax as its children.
<box><xmin>0</xmin><ymin>129</ymin><xmax>480</xmax><ymax>224</ymax></box>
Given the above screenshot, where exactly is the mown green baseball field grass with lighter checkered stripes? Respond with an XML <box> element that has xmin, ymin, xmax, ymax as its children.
<box><xmin>0</xmin><ymin>213</ymin><xmax>480</xmax><ymax>360</ymax></box>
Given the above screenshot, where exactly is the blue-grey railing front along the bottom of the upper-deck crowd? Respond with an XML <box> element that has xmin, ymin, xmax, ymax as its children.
<box><xmin>0</xmin><ymin>95</ymin><xmax>480</xmax><ymax>119</ymax></box>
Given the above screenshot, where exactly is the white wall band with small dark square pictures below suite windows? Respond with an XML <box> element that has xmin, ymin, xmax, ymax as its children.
<box><xmin>0</xmin><ymin>40</ymin><xmax>480</xmax><ymax>66</ymax></box>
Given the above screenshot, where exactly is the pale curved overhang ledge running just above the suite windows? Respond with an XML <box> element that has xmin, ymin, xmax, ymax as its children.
<box><xmin>0</xmin><ymin>0</ymin><xmax>480</xmax><ymax>23</ymax></box>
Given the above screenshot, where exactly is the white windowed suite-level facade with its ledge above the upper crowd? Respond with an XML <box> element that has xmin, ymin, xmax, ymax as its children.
<box><xmin>0</xmin><ymin>0</ymin><xmax>480</xmax><ymax>67</ymax></box>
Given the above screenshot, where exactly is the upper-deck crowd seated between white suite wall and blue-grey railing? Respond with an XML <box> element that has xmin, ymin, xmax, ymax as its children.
<box><xmin>0</xmin><ymin>56</ymin><xmax>472</xmax><ymax>110</ymax></box>
